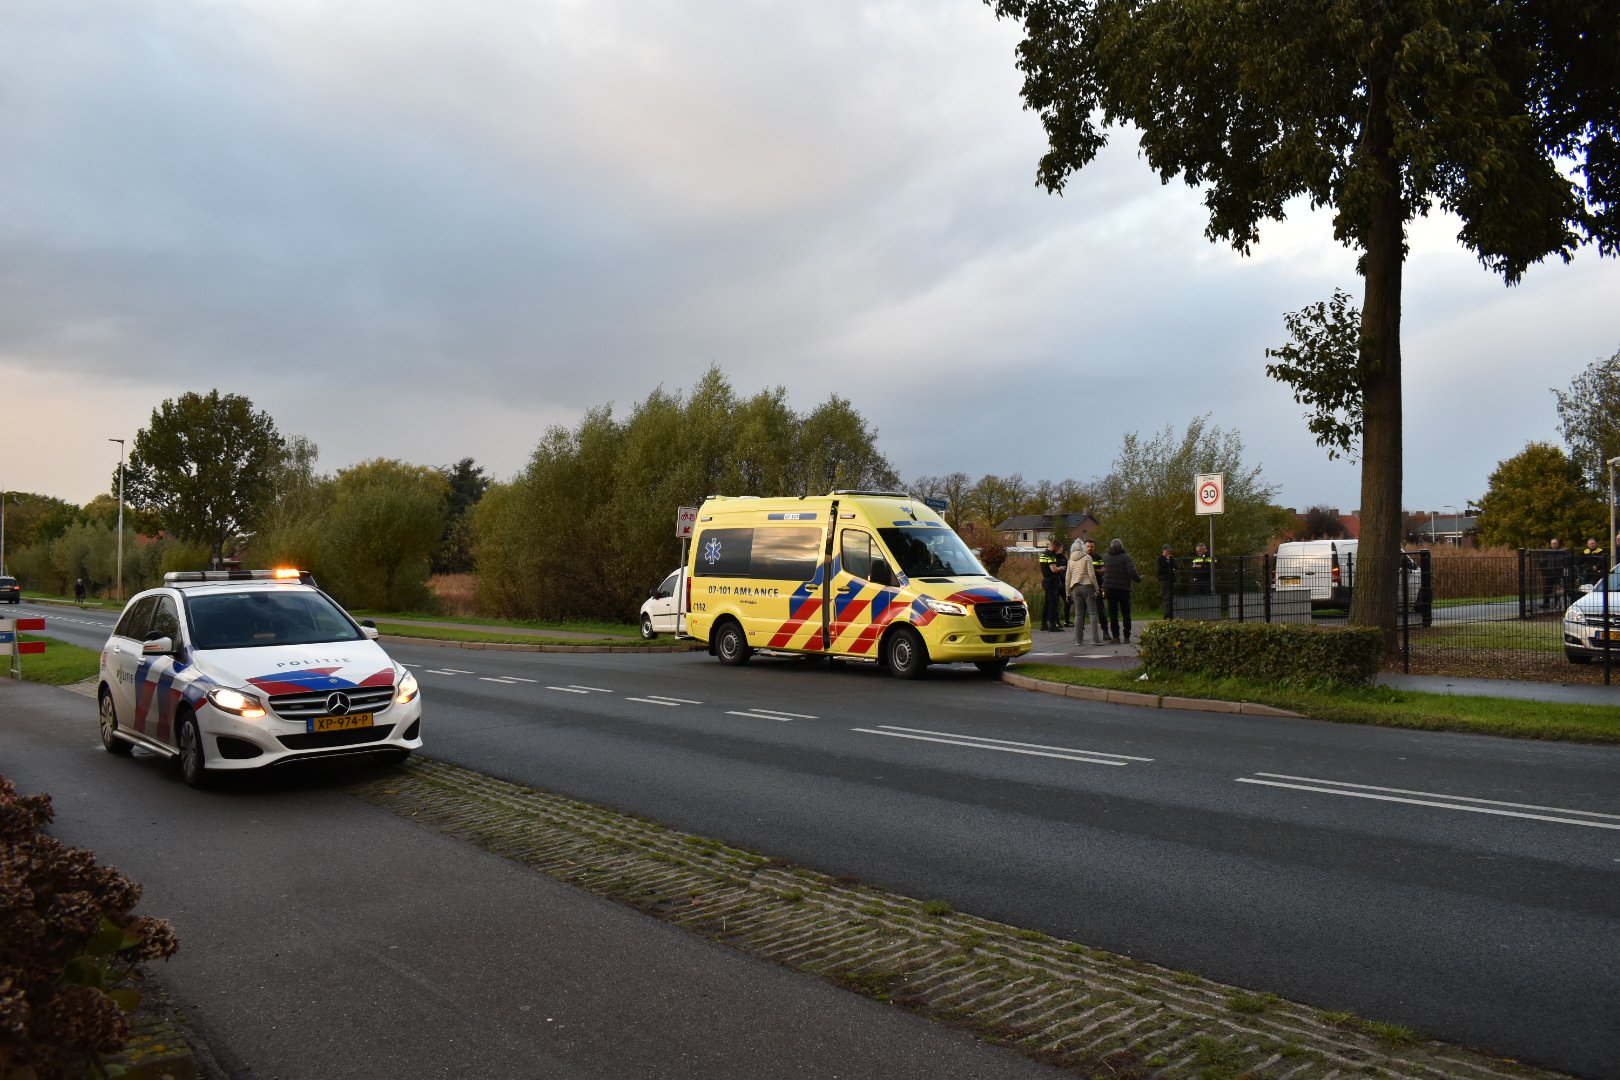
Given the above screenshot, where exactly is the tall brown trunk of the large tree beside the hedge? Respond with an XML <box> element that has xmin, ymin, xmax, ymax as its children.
<box><xmin>1351</xmin><ymin>38</ymin><xmax>1406</xmax><ymax>654</ymax></box>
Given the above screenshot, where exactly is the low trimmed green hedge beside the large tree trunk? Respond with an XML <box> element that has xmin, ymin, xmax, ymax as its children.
<box><xmin>1140</xmin><ymin>619</ymin><xmax>1383</xmax><ymax>685</ymax></box>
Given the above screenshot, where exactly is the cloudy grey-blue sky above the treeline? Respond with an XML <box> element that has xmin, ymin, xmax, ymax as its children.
<box><xmin>0</xmin><ymin>0</ymin><xmax>1620</xmax><ymax>512</ymax></box>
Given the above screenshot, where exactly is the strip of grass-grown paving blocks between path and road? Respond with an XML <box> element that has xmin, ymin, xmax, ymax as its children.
<box><xmin>353</xmin><ymin>756</ymin><xmax>1557</xmax><ymax>1080</ymax></box>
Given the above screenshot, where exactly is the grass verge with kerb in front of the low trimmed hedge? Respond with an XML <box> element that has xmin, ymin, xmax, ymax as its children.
<box><xmin>1013</xmin><ymin>664</ymin><xmax>1620</xmax><ymax>743</ymax></box>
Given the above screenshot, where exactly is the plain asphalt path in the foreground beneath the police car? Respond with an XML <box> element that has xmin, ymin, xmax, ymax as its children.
<box><xmin>0</xmin><ymin>678</ymin><xmax>1058</xmax><ymax>1080</ymax></box>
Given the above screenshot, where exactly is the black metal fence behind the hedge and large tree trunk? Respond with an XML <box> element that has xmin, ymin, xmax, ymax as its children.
<box><xmin>1162</xmin><ymin>549</ymin><xmax>1620</xmax><ymax>683</ymax></box>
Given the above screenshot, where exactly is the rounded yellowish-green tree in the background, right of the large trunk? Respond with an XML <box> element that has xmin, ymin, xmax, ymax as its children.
<box><xmin>1479</xmin><ymin>442</ymin><xmax>1609</xmax><ymax>547</ymax></box>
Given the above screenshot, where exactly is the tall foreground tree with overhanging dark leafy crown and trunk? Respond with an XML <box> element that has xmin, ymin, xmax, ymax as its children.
<box><xmin>985</xmin><ymin>0</ymin><xmax>1620</xmax><ymax>648</ymax></box>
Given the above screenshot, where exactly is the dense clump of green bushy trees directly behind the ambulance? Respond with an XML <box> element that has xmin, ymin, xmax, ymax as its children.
<box><xmin>473</xmin><ymin>368</ymin><xmax>899</xmax><ymax>620</ymax></box>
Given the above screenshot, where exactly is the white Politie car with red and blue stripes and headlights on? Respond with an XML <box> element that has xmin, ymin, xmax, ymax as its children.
<box><xmin>97</xmin><ymin>570</ymin><xmax>421</xmax><ymax>787</ymax></box>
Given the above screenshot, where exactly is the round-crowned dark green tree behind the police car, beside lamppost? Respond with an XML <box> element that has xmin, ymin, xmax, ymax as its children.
<box><xmin>121</xmin><ymin>390</ymin><xmax>287</xmax><ymax>560</ymax></box>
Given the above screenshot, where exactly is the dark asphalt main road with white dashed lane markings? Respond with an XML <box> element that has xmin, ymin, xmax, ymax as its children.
<box><xmin>15</xmin><ymin>612</ymin><xmax>1620</xmax><ymax>1077</ymax></box>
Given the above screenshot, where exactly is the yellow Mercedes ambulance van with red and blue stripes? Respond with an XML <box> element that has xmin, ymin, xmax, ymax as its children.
<box><xmin>687</xmin><ymin>491</ymin><xmax>1030</xmax><ymax>678</ymax></box>
